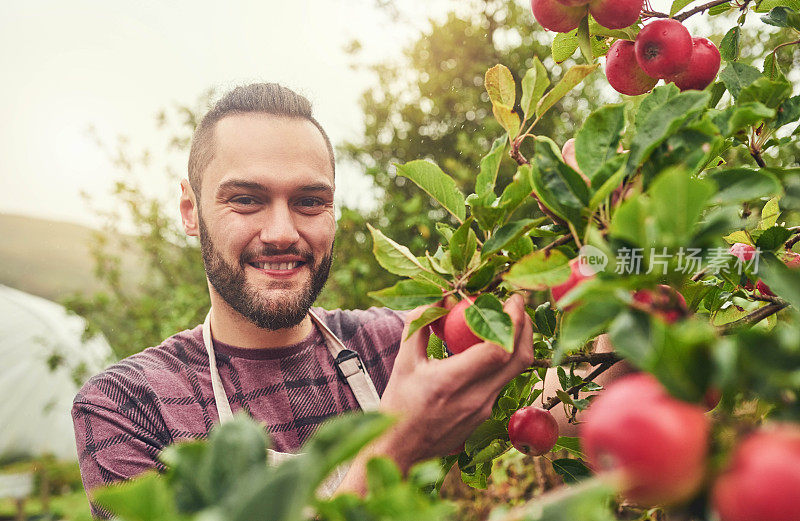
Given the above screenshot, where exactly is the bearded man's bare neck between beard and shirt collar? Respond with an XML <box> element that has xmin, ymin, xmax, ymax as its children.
<box><xmin>211</xmin><ymin>296</ymin><xmax>313</xmax><ymax>349</ymax></box>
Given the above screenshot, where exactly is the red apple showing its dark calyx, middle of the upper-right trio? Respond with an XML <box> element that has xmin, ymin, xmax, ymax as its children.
<box><xmin>635</xmin><ymin>18</ymin><xmax>692</xmax><ymax>78</ymax></box>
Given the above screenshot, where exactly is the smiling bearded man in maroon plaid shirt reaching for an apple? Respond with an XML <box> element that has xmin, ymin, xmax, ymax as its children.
<box><xmin>72</xmin><ymin>84</ymin><xmax>533</xmax><ymax>516</ymax></box>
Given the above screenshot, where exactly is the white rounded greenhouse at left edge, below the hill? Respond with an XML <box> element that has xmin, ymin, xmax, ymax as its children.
<box><xmin>0</xmin><ymin>285</ymin><xmax>111</xmax><ymax>461</ymax></box>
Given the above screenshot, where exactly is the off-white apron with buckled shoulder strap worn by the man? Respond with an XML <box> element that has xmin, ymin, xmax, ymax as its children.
<box><xmin>203</xmin><ymin>309</ymin><xmax>380</xmax><ymax>497</ymax></box>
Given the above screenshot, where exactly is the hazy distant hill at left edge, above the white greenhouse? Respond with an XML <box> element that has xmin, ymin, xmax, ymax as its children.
<box><xmin>0</xmin><ymin>214</ymin><xmax>141</xmax><ymax>302</ymax></box>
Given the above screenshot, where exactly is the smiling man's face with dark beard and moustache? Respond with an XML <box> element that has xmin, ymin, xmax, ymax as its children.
<box><xmin>198</xmin><ymin>114</ymin><xmax>336</xmax><ymax>330</ymax></box>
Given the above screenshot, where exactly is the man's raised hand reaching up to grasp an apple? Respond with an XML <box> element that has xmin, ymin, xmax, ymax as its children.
<box><xmin>375</xmin><ymin>295</ymin><xmax>533</xmax><ymax>471</ymax></box>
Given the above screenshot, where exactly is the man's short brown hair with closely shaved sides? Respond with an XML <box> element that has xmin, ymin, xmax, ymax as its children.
<box><xmin>189</xmin><ymin>83</ymin><xmax>336</xmax><ymax>197</ymax></box>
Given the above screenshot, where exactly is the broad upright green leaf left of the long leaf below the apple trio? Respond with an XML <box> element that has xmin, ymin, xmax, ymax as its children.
<box><xmin>575</xmin><ymin>104</ymin><xmax>625</xmax><ymax>179</ymax></box>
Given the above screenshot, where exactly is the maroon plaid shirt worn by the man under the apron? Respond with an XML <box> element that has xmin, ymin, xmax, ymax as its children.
<box><xmin>72</xmin><ymin>308</ymin><xmax>404</xmax><ymax>516</ymax></box>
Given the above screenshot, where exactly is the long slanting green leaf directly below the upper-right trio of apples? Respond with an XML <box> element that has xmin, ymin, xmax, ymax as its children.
<box><xmin>627</xmin><ymin>90</ymin><xmax>710</xmax><ymax>173</ymax></box>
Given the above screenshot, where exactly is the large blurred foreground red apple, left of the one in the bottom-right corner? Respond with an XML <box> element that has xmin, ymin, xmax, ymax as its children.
<box><xmin>579</xmin><ymin>373</ymin><xmax>709</xmax><ymax>506</ymax></box>
